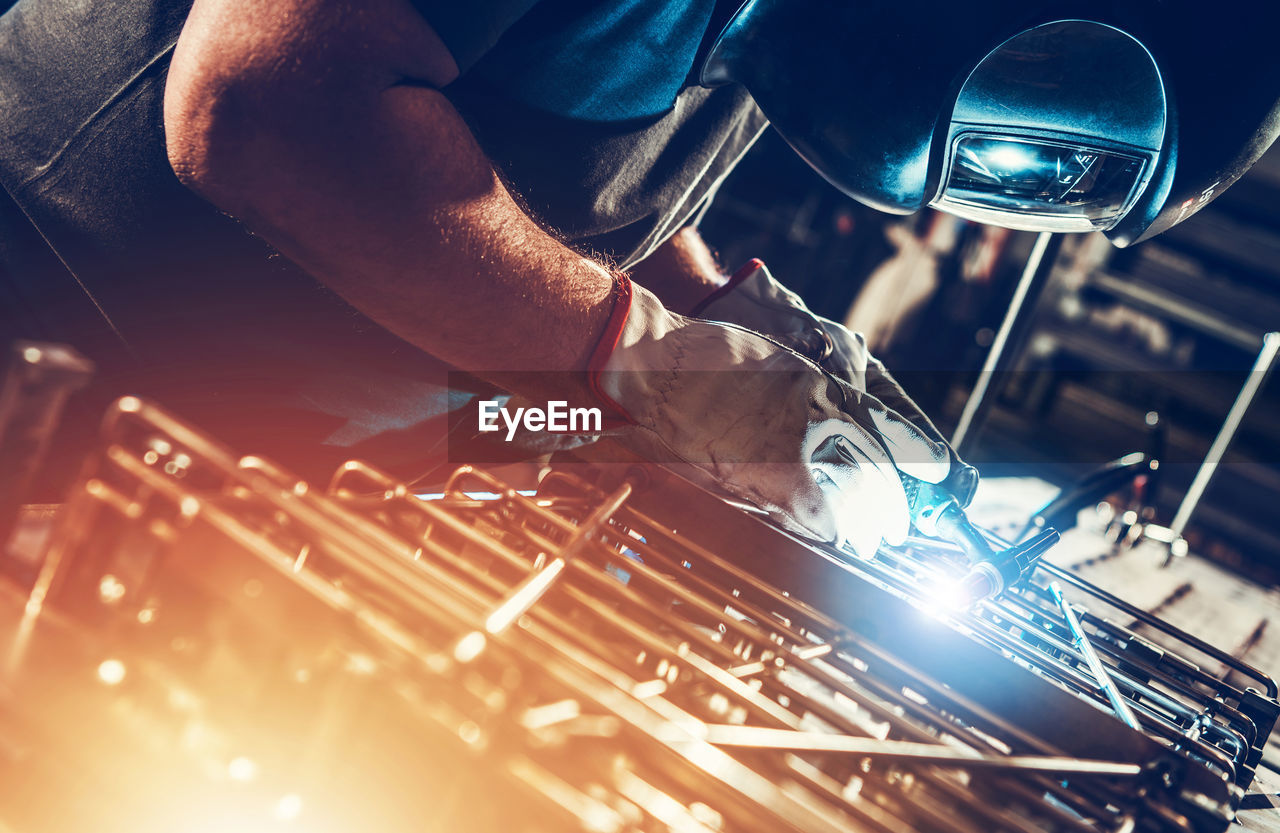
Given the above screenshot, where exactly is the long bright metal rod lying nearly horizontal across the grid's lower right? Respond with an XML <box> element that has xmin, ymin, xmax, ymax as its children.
<box><xmin>662</xmin><ymin>723</ymin><xmax>1142</xmax><ymax>775</ymax></box>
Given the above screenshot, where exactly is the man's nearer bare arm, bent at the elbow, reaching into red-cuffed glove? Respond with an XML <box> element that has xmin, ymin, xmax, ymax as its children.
<box><xmin>164</xmin><ymin>0</ymin><xmax>612</xmax><ymax>393</ymax></box>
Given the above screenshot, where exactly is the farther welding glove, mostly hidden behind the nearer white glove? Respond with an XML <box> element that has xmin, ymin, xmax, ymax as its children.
<box><xmin>691</xmin><ymin>260</ymin><xmax>978</xmax><ymax>507</ymax></box>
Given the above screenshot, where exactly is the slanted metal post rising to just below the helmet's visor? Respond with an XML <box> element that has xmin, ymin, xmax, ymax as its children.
<box><xmin>951</xmin><ymin>232</ymin><xmax>1061</xmax><ymax>457</ymax></box>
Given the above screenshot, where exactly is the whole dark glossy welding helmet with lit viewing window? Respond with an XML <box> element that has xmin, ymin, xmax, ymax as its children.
<box><xmin>701</xmin><ymin>0</ymin><xmax>1280</xmax><ymax>246</ymax></box>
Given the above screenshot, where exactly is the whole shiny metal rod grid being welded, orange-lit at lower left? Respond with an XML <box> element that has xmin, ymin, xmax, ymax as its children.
<box><xmin>0</xmin><ymin>399</ymin><xmax>1275</xmax><ymax>833</ymax></box>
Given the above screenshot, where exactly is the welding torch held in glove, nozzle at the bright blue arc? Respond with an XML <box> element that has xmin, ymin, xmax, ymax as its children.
<box><xmin>901</xmin><ymin>475</ymin><xmax>1060</xmax><ymax>607</ymax></box>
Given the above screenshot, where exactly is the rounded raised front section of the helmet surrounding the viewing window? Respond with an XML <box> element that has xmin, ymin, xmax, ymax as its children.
<box><xmin>931</xmin><ymin>20</ymin><xmax>1166</xmax><ymax>232</ymax></box>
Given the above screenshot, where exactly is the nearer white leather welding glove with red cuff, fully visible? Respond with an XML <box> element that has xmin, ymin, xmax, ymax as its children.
<box><xmin>590</xmin><ymin>280</ymin><xmax>950</xmax><ymax>558</ymax></box>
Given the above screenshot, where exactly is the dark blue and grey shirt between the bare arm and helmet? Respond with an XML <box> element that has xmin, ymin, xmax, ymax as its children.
<box><xmin>416</xmin><ymin>0</ymin><xmax>765</xmax><ymax>266</ymax></box>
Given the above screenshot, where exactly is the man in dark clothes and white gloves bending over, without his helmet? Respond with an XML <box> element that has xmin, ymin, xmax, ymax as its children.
<box><xmin>0</xmin><ymin>0</ymin><xmax>1274</xmax><ymax>553</ymax></box>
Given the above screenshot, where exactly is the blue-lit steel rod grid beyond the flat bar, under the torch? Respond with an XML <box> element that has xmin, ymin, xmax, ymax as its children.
<box><xmin>856</xmin><ymin>536</ymin><xmax>1280</xmax><ymax>788</ymax></box>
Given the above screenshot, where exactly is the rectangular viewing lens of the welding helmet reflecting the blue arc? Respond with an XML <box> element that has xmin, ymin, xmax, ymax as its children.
<box><xmin>933</xmin><ymin>134</ymin><xmax>1146</xmax><ymax>232</ymax></box>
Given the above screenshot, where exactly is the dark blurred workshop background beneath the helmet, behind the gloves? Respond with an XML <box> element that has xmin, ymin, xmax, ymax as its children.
<box><xmin>701</xmin><ymin>132</ymin><xmax>1280</xmax><ymax>586</ymax></box>
